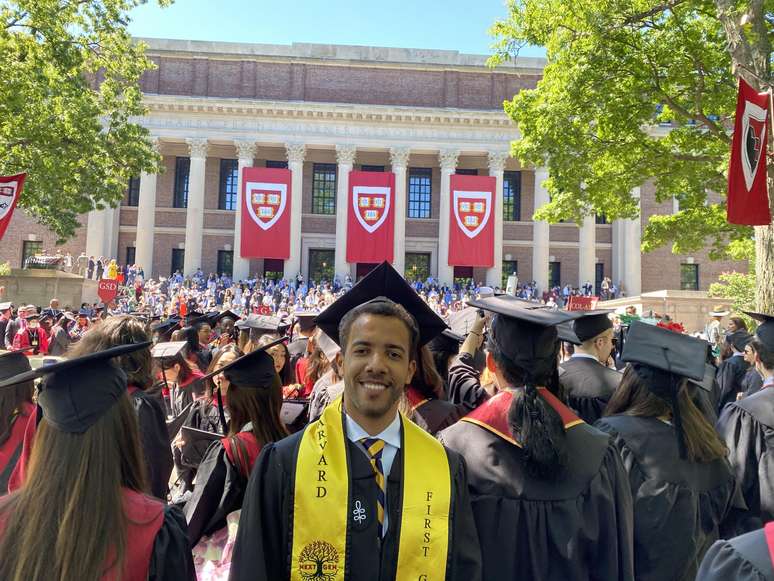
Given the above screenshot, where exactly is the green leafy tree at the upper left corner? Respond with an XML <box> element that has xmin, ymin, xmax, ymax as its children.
<box><xmin>0</xmin><ymin>0</ymin><xmax>169</xmax><ymax>239</ymax></box>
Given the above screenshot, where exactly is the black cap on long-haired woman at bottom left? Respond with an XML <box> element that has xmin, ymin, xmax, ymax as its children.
<box><xmin>0</xmin><ymin>342</ymin><xmax>150</xmax><ymax>434</ymax></box>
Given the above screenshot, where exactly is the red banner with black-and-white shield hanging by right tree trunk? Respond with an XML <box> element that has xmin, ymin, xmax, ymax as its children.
<box><xmin>728</xmin><ymin>79</ymin><xmax>771</xmax><ymax>226</ymax></box>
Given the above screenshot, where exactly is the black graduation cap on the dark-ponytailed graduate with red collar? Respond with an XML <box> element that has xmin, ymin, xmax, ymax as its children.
<box><xmin>468</xmin><ymin>295</ymin><xmax>583</xmax><ymax>383</ymax></box>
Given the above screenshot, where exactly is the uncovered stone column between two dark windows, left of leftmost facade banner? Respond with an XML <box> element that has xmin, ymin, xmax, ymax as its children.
<box><xmin>183</xmin><ymin>139</ymin><xmax>207</xmax><ymax>275</ymax></box>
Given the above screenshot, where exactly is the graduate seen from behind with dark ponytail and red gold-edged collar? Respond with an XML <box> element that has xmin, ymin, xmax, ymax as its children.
<box><xmin>438</xmin><ymin>297</ymin><xmax>634</xmax><ymax>581</ymax></box>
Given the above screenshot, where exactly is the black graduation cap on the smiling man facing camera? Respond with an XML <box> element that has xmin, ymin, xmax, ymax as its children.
<box><xmin>317</xmin><ymin>261</ymin><xmax>446</xmax><ymax>346</ymax></box>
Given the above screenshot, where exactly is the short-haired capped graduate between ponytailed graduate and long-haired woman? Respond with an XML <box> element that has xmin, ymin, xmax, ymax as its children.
<box><xmin>559</xmin><ymin>311</ymin><xmax>621</xmax><ymax>424</ymax></box>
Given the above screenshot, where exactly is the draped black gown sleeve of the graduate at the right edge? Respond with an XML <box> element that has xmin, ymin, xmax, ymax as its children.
<box><xmin>717</xmin><ymin>405</ymin><xmax>766</xmax><ymax>537</ymax></box>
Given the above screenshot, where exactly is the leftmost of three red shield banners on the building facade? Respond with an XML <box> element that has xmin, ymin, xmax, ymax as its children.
<box><xmin>240</xmin><ymin>167</ymin><xmax>291</xmax><ymax>259</ymax></box>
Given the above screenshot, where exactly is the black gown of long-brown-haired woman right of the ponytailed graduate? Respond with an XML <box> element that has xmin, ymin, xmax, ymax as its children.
<box><xmin>595</xmin><ymin>415</ymin><xmax>735</xmax><ymax>581</ymax></box>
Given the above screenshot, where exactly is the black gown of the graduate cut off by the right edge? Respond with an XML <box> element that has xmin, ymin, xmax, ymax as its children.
<box><xmin>717</xmin><ymin>388</ymin><xmax>774</xmax><ymax>536</ymax></box>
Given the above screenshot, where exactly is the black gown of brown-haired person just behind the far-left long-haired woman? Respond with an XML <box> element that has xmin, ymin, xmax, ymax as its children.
<box><xmin>132</xmin><ymin>389</ymin><xmax>173</xmax><ymax>501</ymax></box>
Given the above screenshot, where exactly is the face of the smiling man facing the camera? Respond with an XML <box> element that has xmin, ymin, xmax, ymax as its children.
<box><xmin>343</xmin><ymin>314</ymin><xmax>416</xmax><ymax>435</ymax></box>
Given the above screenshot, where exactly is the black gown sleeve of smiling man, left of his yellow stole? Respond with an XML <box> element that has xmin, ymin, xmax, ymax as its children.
<box><xmin>231</xmin><ymin>444</ymin><xmax>292</xmax><ymax>581</ymax></box>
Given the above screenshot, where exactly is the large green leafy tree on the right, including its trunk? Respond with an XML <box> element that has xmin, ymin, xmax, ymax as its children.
<box><xmin>491</xmin><ymin>0</ymin><xmax>774</xmax><ymax>311</ymax></box>
